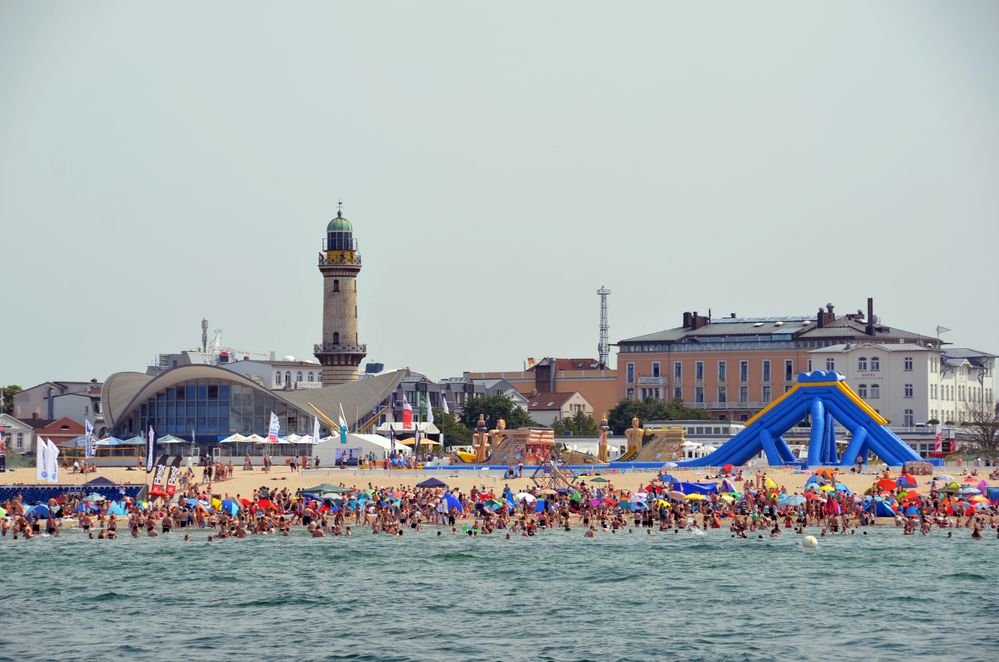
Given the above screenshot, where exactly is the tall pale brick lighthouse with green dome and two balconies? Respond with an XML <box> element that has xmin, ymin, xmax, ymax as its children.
<box><xmin>315</xmin><ymin>203</ymin><xmax>367</xmax><ymax>386</ymax></box>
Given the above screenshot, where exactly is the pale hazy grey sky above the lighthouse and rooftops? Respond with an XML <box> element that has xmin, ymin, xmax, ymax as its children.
<box><xmin>0</xmin><ymin>0</ymin><xmax>999</xmax><ymax>386</ymax></box>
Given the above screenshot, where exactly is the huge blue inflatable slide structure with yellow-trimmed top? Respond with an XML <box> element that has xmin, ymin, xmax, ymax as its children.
<box><xmin>679</xmin><ymin>370</ymin><xmax>922</xmax><ymax>467</ymax></box>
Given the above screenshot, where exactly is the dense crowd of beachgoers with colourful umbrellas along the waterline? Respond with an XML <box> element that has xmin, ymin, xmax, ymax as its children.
<box><xmin>0</xmin><ymin>465</ymin><xmax>999</xmax><ymax>540</ymax></box>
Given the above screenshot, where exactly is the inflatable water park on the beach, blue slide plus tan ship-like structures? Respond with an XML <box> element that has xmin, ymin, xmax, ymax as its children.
<box><xmin>448</xmin><ymin>370</ymin><xmax>928</xmax><ymax>470</ymax></box>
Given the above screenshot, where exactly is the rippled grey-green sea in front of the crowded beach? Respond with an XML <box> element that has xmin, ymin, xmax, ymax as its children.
<box><xmin>0</xmin><ymin>527</ymin><xmax>999</xmax><ymax>662</ymax></box>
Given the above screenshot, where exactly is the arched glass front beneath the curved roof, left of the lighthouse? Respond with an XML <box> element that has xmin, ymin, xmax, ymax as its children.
<box><xmin>122</xmin><ymin>380</ymin><xmax>312</xmax><ymax>441</ymax></box>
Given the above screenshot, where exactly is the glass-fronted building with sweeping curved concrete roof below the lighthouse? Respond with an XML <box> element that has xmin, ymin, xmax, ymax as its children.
<box><xmin>101</xmin><ymin>365</ymin><xmax>403</xmax><ymax>442</ymax></box>
